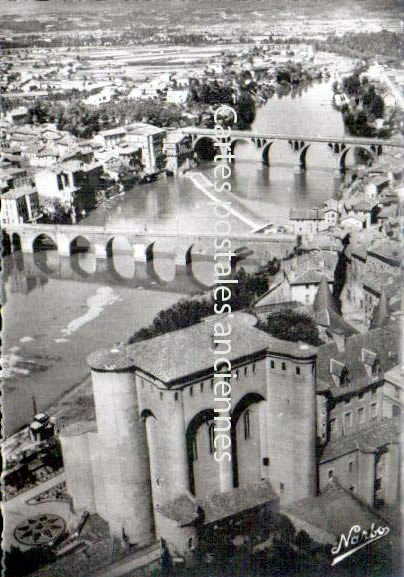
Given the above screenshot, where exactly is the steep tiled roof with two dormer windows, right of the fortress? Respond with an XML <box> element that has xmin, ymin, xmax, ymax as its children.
<box><xmin>317</xmin><ymin>324</ymin><xmax>400</xmax><ymax>397</ymax></box>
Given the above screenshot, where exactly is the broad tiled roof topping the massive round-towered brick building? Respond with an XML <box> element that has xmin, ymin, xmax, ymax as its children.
<box><xmin>127</xmin><ymin>313</ymin><xmax>316</xmax><ymax>384</ymax></box>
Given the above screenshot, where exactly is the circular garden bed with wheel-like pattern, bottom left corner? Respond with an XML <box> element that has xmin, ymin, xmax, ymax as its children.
<box><xmin>14</xmin><ymin>513</ymin><xmax>66</xmax><ymax>547</ymax></box>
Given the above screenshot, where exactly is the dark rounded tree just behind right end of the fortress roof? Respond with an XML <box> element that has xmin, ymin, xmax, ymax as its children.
<box><xmin>258</xmin><ymin>309</ymin><xmax>321</xmax><ymax>346</ymax></box>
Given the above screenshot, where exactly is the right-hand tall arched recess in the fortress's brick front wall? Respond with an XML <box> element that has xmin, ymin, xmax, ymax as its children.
<box><xmin>231</xmin><ymin>392</ymin><xmax>265</xmax><ymax>487</ymax></box>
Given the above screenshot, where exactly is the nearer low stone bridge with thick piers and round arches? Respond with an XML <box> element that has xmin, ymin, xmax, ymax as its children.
<box><xmin>4</xmin><ymin>223</ymin><xmax>296</xmax><ymax>286</ymax></box>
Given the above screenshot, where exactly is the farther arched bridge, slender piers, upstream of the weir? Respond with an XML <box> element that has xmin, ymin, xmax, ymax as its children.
<box><xmin>181</xmin><ymin>127</ymin><xmax>404</xmax><ymax>172</ymax></box>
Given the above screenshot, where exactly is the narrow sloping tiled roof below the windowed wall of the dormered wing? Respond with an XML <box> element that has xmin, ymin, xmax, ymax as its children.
<box><xmin>320</xmin><ymin>419</ymin><xmax>399</xmax><ymax>463</ymax></box>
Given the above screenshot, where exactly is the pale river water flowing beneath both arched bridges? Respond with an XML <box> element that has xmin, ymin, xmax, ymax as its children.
<box><xmin>3</xmin><ymin>61</ymin><xmax>356</xmax><ymax>433</ymax></box>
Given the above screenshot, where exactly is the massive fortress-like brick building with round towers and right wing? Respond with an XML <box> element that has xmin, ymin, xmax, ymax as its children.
<box><xmin>60</xmin><ymin>313</ymin><xmax>398</xmax><ymax>559</ymax></box>
